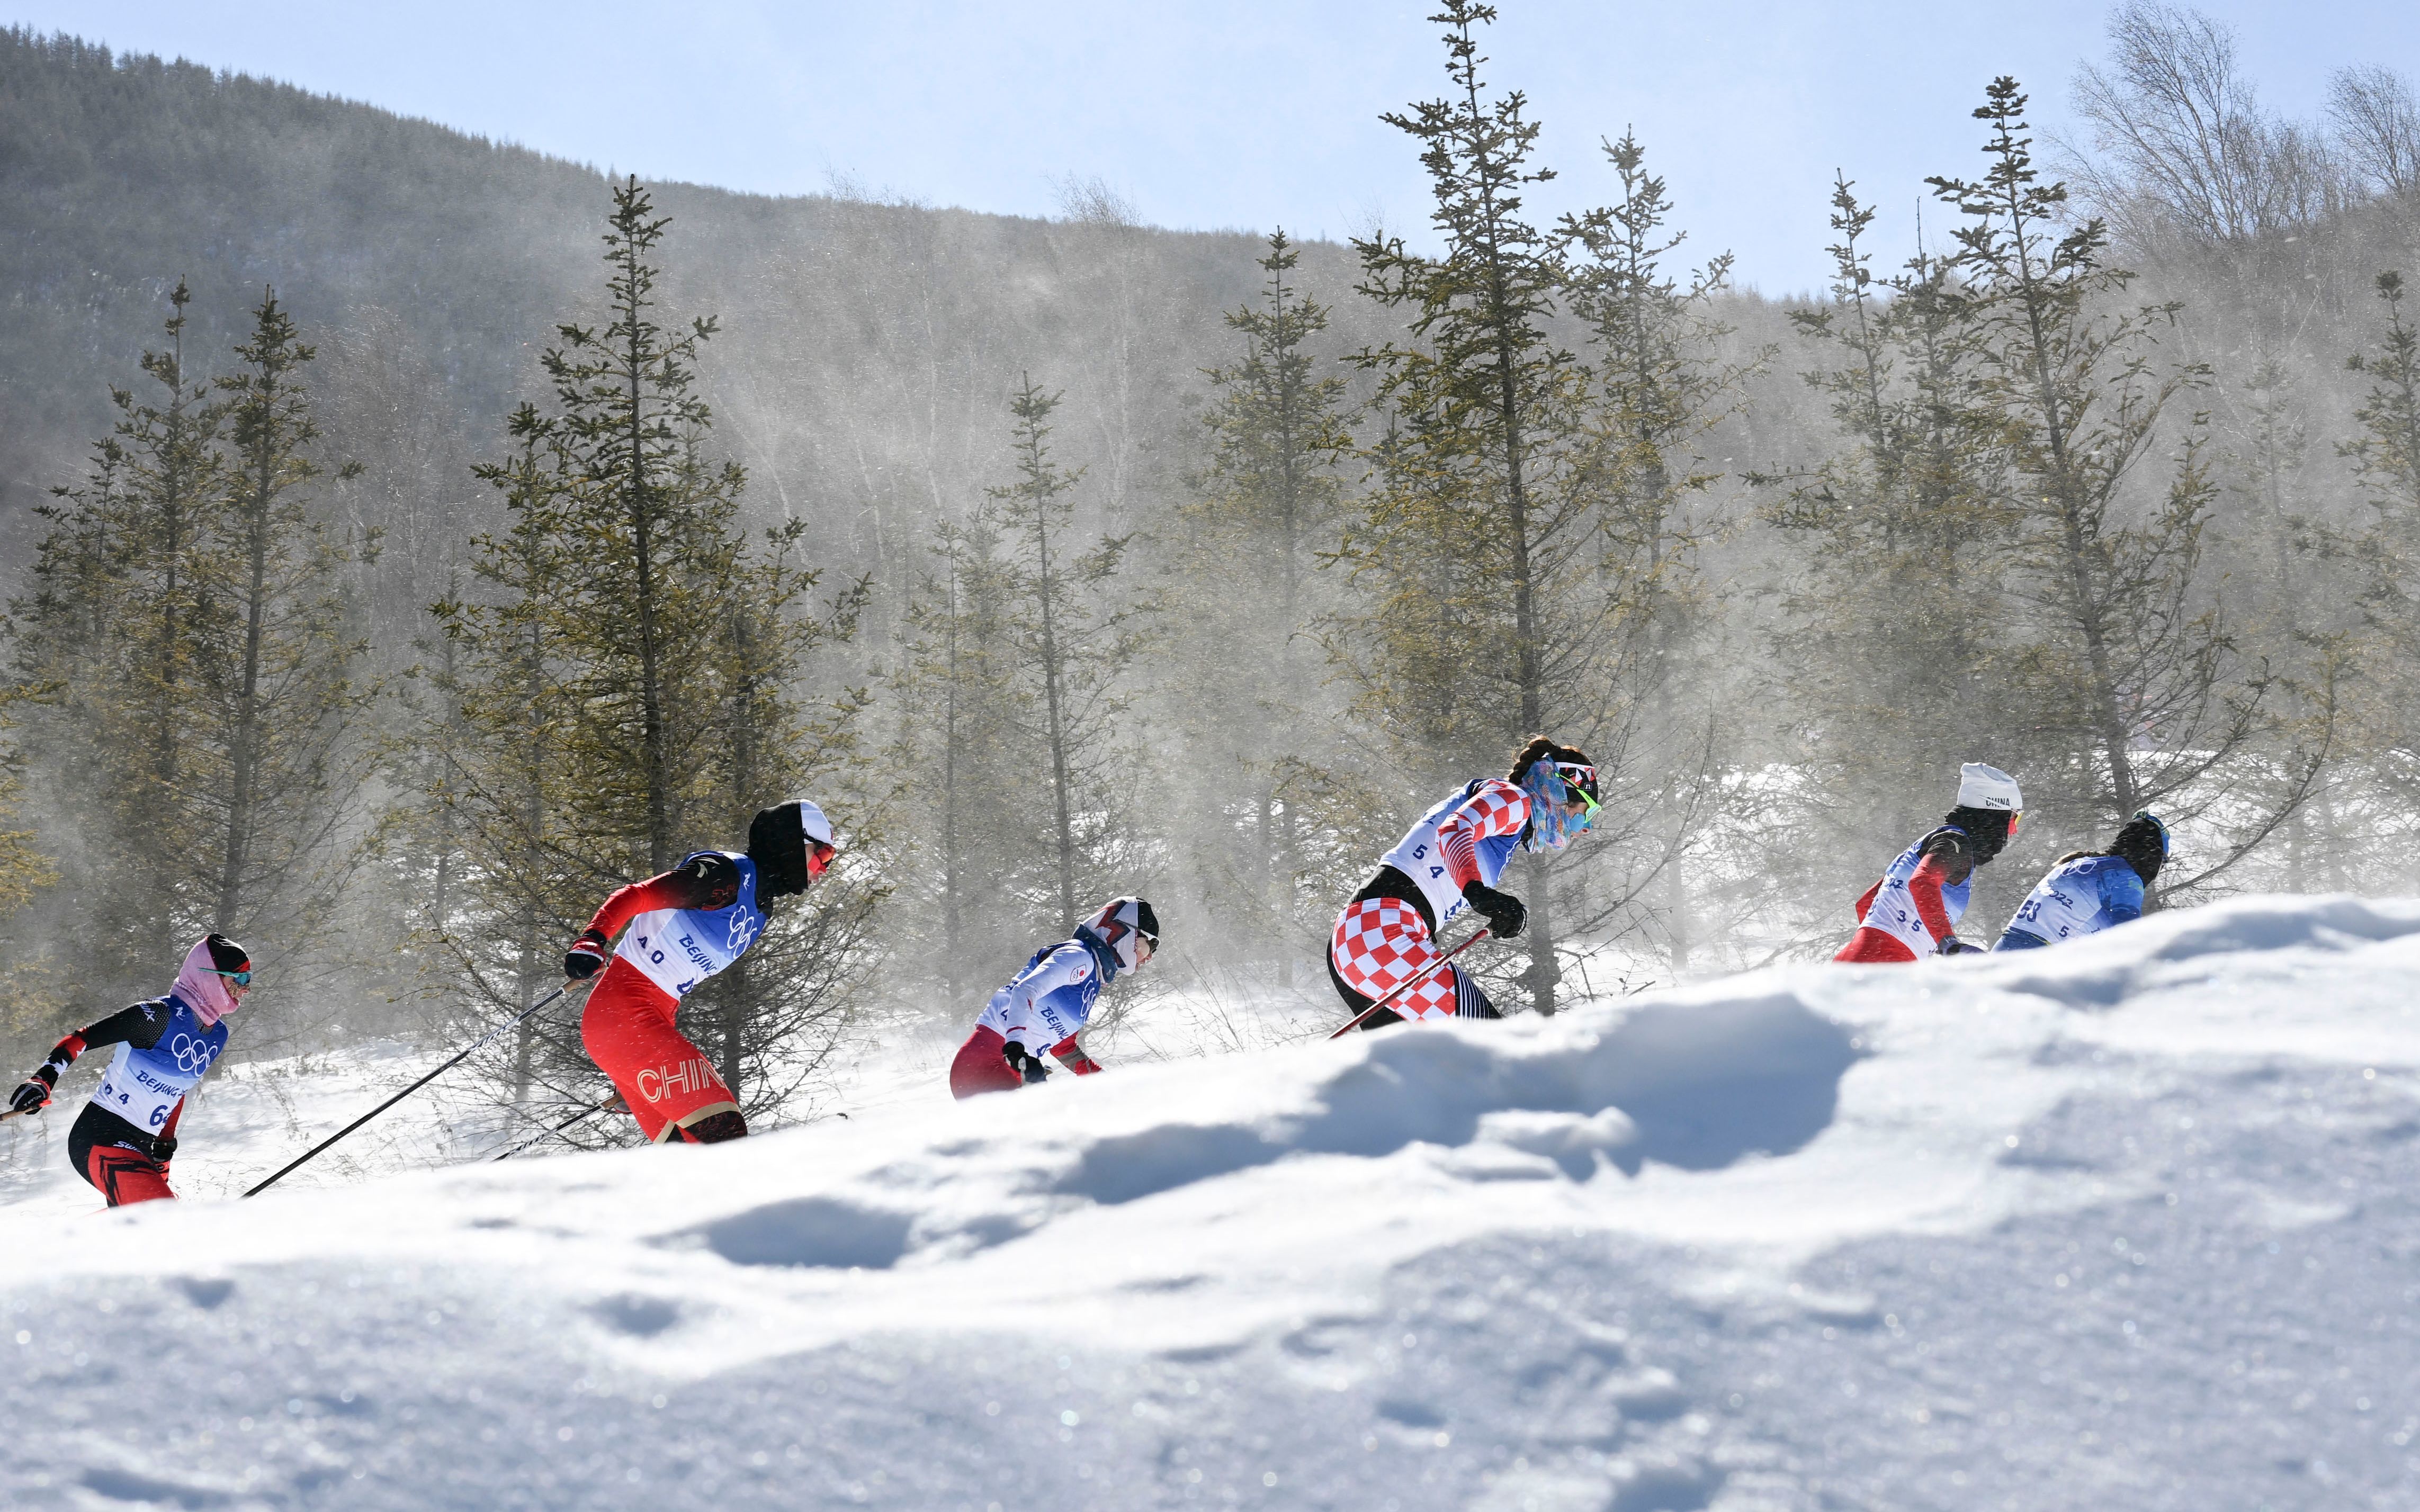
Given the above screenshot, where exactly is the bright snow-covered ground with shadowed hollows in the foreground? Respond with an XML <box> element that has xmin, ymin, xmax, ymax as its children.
<box><xmin>0</xmin><ymin>897</ymin><xmax>2420</xmax><ymax>1512</ymax></box>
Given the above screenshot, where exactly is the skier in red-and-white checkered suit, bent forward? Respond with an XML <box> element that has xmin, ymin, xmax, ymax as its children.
<box><xmin>1329</xmin><ymin>735</ymin><xmax>1597</xmax><ymax>1028</ymax></box>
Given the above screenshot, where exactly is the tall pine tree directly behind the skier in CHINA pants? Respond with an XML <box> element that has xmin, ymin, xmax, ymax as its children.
<box><xmin>428</xmin><ymin>179</ymin><xmax>874</xmax><ymax>1127</ymax></box>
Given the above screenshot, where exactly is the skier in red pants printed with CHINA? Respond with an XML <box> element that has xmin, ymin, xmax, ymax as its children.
<box><xmin>564</xmin><ymin>798</ymin><xmax>837</xmax><ymax>1144</ymax></box>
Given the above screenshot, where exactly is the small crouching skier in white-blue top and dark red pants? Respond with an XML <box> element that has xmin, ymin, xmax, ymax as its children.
<box><xmin>948</xmin><ymin>897</ymin><xmax>1159</xmax><ymax>1099</ymax></box>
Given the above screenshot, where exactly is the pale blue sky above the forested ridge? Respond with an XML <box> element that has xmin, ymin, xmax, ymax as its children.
<box><xmin>19</xmin><ymin>0</ymin><xmax>2420</xmax><ymax>293</ymax></box>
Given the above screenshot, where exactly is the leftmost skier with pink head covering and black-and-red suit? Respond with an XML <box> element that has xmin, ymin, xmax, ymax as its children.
<box><xmin>7</xmin><ymin>934</ymin><xmax>252</xmax><ymax>1207</ymax></box>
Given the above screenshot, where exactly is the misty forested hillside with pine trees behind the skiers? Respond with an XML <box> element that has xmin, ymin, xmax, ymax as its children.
<box><xmin>0</xmin><ymin>3</ymin><xmax>2420</xmax><ymax>1132</ymax></box>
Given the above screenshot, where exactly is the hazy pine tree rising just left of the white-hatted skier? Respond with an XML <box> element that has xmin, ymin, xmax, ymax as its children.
<box><xmin>1767</xmin><ymin>177</ymin><xmax>2013</xmax><ymax>946</ymax></box>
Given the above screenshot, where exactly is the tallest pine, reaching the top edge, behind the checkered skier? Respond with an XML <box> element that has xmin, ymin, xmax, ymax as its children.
<box><xmin>1341</xmin><ymin>0</ymin><xmax>1607</xmax><ymax>1014</ymax></box>
